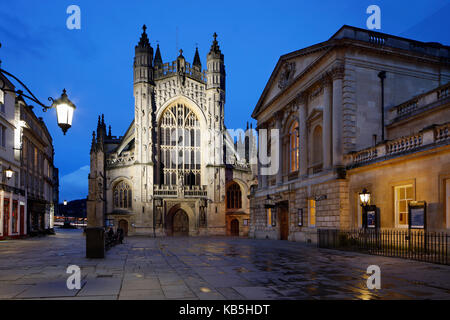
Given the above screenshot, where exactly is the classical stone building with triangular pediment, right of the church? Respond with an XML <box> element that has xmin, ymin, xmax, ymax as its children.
<box><xmin>250</xmin><ymin>26</ymin><xmax>450</xmax><ymax>242</ymax></box>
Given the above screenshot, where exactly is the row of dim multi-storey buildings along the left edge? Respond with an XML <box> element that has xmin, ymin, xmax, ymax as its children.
<box><xmin>0</xmin><ymin>76</ymin><xmax>58</xmax><ymax>238</ymax></box>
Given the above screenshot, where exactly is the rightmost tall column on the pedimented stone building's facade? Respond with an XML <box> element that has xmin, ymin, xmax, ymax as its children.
<box><xmin>331</xmin><ymin>66</ymin><xmax>344</xmax><ymax>167</ymax></box>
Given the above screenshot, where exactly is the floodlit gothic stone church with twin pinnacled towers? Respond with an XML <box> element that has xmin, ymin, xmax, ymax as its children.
<box><xmin>88</xmin><ymin>26</ymin><xmax>255</xmax><ymax>236</ymax></box>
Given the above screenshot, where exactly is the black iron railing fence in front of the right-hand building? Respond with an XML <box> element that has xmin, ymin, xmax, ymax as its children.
<box><xmin>317</xmin><ymin>229</ymin><xmax>450</xmax><ymax>265</ymax></box>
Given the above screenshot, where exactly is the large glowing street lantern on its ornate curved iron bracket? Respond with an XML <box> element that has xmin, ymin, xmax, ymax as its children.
<box><xmin>0</xmin><ymin>43</ymin><xmax>75</xmax><ymax>135</ymax></box>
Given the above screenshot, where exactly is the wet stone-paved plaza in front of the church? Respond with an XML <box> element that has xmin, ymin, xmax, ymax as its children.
<box><xmin>0</xmin><ymin>230</ymin><xmax>450</xmax><ymax>300</ymax></box>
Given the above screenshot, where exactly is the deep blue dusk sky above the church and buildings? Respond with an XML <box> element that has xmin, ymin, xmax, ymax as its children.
<box><xmin>0</xmin><ymin>0</ymin><xmax>450</xmax><ymax>200</ymax></box>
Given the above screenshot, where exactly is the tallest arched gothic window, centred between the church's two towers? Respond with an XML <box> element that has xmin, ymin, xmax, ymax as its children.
<box><xmin>158</xmin><ymin>104</ymin><xmax>201</xmax><ymax>185</ymax></box>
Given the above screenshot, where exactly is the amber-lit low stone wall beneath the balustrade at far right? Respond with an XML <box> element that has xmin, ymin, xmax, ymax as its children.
<box><xmin>347</xmin><ymin>145</ymin><xmax>450</xmax><ymax>230</ymax></box>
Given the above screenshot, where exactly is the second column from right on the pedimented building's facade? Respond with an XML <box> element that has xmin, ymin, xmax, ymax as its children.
<box><xmin>322</xmin><ymin>75</ymin><xmax>331</xmax><ymax>169</ymax></box>
